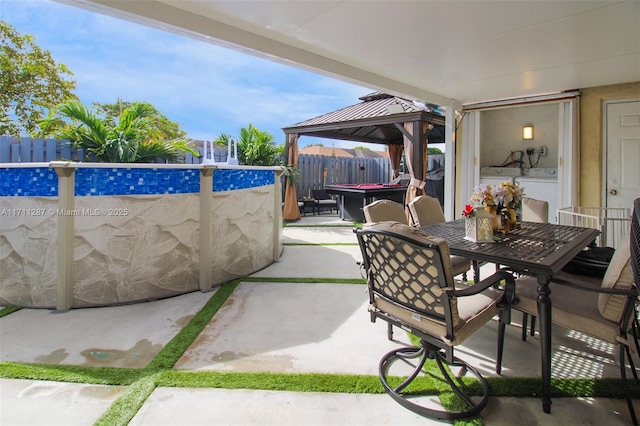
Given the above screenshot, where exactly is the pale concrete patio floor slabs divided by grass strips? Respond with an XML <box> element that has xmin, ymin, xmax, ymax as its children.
<box><xmin>0</xmin><ymin>214</ymin><xmax>640</xmax><ymax>425</ymax></box>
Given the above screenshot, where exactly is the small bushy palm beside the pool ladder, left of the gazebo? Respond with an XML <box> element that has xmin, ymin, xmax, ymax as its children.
<box><xmin>215</xmin><ymin>123</ymin><xmax>284</xmax><ymax>166</ymax></box>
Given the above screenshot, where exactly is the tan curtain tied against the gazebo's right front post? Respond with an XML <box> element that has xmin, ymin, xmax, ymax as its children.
<box><xmin>403</xmin><ymin>121</ymin><xmax>428</xmax><ymax>221</ymax></box>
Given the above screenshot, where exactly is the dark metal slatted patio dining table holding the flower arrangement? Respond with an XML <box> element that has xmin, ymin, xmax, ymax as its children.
<box><xmin>422</xmin><ymin>219</ymin><xmax>599</xmax><ymax>413</ymax></box>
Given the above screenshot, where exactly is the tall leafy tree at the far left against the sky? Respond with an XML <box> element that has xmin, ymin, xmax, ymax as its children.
<box><xmin>0</xmin><ymin>21</ymin><xmax>77</xmax><ymax>136</ymax></box>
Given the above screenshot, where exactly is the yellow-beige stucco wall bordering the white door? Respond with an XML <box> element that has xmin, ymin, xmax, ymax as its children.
<box><xmin>579</xmin><ymin>81</ymin><xmax>640</xmax><ymax>207</ymax></box>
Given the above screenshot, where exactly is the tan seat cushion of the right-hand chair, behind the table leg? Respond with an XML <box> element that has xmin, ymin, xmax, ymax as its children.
<box><xmin>514</xmin><ymin>272</ymin><xmax>620</xmax><ymax>344</ymax></box>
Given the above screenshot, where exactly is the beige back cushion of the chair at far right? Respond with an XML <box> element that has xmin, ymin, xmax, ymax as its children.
<box><xmin>598</xmin><ymin>232</ymin><xmax>633</xmax><ymax>322</ymax></box>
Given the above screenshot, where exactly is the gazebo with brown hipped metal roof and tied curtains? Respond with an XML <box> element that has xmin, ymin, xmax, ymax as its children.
<box><xmin>282</xmin><ymin>92</ymin><xmax>445</xmax><ymax>221</ymax></box>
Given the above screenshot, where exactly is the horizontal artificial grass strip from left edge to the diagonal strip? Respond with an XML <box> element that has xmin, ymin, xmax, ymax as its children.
<box><xmin>0</xmin><ymin>362</ymin><xmax>145</xmax><ymax>386</ymax></box>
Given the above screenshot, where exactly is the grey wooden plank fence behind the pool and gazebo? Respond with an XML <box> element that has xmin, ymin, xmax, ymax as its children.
<box><xmin>0</xmin><ymin>136</ymin><xmax>444</xmax><ymax>203</ymax></box>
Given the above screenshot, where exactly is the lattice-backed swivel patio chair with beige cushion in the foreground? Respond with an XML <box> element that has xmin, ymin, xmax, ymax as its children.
<box><xmin>354</xmin><ymin>222</ymin><xmax>514</xmax><ymax>420</ymax></box>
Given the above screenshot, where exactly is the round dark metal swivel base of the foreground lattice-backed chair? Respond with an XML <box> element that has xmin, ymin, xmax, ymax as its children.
<box><xmin>379</xmin><ymin>341</ymin><xmax>489</xmax><ymax>420</ymax></box>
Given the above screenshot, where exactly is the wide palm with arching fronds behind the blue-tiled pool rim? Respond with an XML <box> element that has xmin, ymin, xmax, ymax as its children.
<box><xmin>42</xmin><ymin>101</ymin><xmax>198</xmax><ymax>163</ymax></box>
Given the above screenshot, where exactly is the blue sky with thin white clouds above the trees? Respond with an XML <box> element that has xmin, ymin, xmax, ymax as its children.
<box><xmin>0</xmin><ymin>0</ymin><xmax>380</xmax><ymax>149</ymax></box>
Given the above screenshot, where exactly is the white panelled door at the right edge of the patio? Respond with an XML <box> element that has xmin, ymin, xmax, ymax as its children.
<box><xmin>605</xmin><ymin>101</ymin><xmax>640</xmax><ymax>208</ymax></box>
